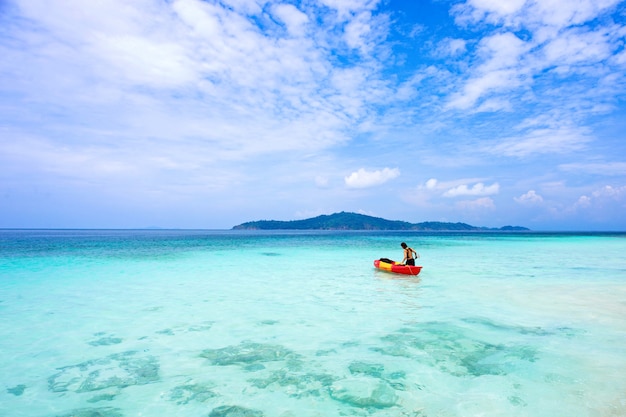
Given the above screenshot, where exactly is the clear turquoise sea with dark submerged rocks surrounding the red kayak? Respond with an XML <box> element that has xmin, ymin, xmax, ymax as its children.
<box><xmin>0</xmin><ymin>230</ymin><xmax>626</xmax><ymax>417</ymax></box>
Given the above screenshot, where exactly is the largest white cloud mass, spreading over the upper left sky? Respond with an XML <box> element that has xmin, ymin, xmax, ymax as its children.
<box><xmin>0</xmin><ymin>0</ymin><xmax>389</xmax><ymax>164</ymax></box>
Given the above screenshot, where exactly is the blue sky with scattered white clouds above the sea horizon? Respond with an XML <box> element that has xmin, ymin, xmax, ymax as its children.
<box><xmin>0</xmin><ymin>0</ymin><xmax>626</xmax><ymax>230</ymax></box>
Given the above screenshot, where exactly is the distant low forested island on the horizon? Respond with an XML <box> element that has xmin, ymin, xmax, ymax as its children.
<box><xmin>233</xmin><ymin>211</ymin><xmax>530</xmax><ymax>232</ymax></box>
